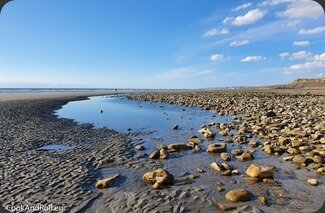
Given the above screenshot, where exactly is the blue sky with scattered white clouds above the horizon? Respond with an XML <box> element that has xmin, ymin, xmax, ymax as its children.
<box><xmin>0</xmin><ymin>0</ymin><xmax>325</xmax><ymax>88</ymax></box>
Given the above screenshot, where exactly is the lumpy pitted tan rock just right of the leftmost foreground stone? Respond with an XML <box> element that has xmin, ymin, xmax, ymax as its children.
<box><xmin>143</xmin><ymin>169</ymin><xmax>174</xmax><ymax>189</ymax></box>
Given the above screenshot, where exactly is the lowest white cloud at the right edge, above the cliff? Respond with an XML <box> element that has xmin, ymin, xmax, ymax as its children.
<box><xmin>284</xmin><ymin>53</ymin><xmax>325</xmax><ymax>74</ymax></box>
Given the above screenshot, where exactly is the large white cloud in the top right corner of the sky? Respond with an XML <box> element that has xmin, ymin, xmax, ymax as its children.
<box><xmin>277</xmin><ymin>0</ymin><xmax>324</xmax><ymax>19</ymax></box>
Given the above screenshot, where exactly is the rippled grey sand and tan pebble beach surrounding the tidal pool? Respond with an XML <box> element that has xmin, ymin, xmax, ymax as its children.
<box><xmin>0</xmin><ymin>90</ymin><xmax>325</xmax><ymax>212</ymax></box>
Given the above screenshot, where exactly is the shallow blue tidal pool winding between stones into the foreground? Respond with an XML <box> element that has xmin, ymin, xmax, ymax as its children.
<box><xmin>57</xmin><ymin>96</ymin><xmax>324</xmax><ymax>212</ymax></box>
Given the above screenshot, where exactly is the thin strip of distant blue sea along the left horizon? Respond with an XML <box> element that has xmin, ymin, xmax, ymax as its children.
<box><xmin>0</xmin><ymin>88</ymin><xmax>137</xmax><ymax>93</ymax></box>
